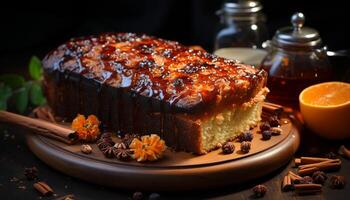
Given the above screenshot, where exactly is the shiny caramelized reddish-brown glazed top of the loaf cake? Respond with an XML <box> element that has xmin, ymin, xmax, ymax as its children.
<box><xmin>43</xmin><ymin>33</ymin><xmax>267</xmax><ymax>111</ymax></box>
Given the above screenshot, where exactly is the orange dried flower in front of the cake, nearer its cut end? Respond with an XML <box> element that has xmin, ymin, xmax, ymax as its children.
<box><xmin>130</xmin><ymin>134</ymin><xmax>166</xmax><ymax>162</ymax></box>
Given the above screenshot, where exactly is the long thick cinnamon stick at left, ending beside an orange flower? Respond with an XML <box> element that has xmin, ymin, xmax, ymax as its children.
<box><xmin>0</xmin><ymin>111</ymin><xmax>78</xmax><ymax>144</ymax></box>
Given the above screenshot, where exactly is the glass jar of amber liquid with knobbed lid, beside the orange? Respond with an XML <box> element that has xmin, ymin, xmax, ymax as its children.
<box><xmin>260</xmin><ymin>13</ymin><xmax>332</xmax><ymax>107</ymax></box>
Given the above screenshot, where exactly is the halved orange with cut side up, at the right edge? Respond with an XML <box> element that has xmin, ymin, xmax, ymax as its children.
<box><xmin>299</xmin><ymin>82</ymin><xmax>350</xmax><ymax>139</ymax></box>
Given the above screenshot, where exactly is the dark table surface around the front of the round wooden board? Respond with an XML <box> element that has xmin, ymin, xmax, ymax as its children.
<box><xmin>0</xmin><ymin>124</ymin><xmax>350</xmax><ymax>200</ymax></box>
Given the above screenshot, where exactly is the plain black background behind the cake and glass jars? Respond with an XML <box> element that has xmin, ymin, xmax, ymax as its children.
<box><xmin>0</xmin><ymin>0</ymin><xmax>350</xmax><ymax>73</ymax></box>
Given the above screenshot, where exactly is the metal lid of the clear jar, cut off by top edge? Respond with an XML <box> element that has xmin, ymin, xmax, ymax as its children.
<box><xmin>216</xmin><ymin>1</ymin><xmax>262</xmax><ymax>16</ymax></box>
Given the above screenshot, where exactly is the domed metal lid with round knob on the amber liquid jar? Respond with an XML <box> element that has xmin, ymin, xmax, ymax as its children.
<box><xmin>272</xmin><ymin>12</ymin><xmax>322</xmax><ymax>48</ymax></box>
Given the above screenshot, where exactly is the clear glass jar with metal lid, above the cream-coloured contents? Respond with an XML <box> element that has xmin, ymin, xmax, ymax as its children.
<box><xmin>214</xmin><ymin>1</ymin><xmax>268</xmax><ymax>50</ymax></box>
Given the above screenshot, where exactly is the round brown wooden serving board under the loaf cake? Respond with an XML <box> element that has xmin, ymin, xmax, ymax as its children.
<box><xmin>27</xmin><ymin>118</ymin><xmax>300</xmax><ymax>191</ymax></box>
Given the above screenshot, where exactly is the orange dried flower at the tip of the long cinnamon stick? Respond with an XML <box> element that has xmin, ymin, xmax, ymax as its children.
<box><xmin>72</xmin><ymin>114</ymin><xmax>100</xmax><ymax>142</ymax></box>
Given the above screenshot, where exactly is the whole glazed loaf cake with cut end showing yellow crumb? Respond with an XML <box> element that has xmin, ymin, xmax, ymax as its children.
<box><xmin>43</xmin><ymin>33</ymin><xmax>268</xmax><ymax>154</ymax></box>
